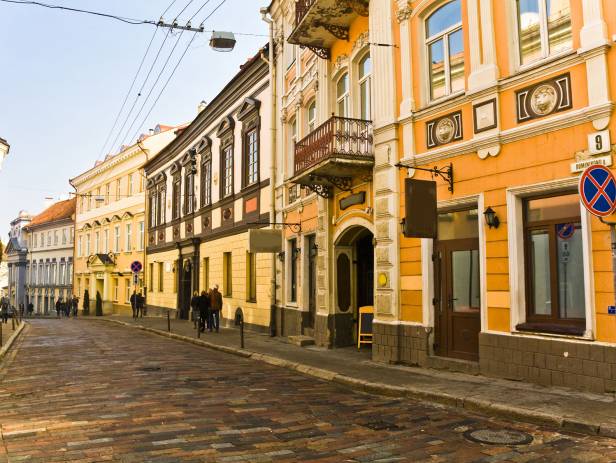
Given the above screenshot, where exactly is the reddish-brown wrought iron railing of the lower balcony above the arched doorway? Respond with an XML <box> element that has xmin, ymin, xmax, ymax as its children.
<box><xmin>295</xmin><ymin>116</ymin><xmax>374</xmax><ymax>176</ymax></box>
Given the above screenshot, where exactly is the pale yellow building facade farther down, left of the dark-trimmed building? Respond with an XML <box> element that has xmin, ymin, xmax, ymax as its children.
<box><xmin>70</xmin><ymin>126</ymin><xmax>176</xmax><ymax>315</ymax></box>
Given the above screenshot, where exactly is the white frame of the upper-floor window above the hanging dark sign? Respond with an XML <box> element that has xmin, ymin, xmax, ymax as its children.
<box><xmin>422</xmin><ymin>0</ymin><xmax>464</xmax><ymax>103</ymax></box>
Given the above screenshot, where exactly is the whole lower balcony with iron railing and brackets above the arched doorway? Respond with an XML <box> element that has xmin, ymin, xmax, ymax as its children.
<box><xmin>291</xmin><ymin>116</ymin><xmax>374</xmax><ymax>198</ymax></box>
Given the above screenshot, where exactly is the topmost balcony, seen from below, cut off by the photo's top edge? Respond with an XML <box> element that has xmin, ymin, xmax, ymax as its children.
<box><xmin>288</xmin><ymin>0</ymin><xmax>370</xmax><ymax>59</ymax></box>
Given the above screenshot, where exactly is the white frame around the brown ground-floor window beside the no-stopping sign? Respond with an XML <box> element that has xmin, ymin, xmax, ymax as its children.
<box><xmin>507</xmin><ymin>177</ymin><xmax>597</xmax><ymax>339</ymax></box>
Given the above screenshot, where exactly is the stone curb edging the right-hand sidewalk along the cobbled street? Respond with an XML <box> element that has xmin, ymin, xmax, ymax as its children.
<box><xmin>98</xmin><ymin>318</ymin><xmax>616</xmax><ymax>437</ymax></box>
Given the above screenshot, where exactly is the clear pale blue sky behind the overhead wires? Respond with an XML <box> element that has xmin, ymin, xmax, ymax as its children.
<box><xmin>0</xmin><ymin>0</ymin><xmax>269</xmax><ymax>236</ymax></box>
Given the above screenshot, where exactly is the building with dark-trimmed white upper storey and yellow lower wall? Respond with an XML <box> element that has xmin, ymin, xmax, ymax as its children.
<box><xmin>145</xmin><ymin>47</ymin><xmax>274</xmax><ymax>332</ymax></box>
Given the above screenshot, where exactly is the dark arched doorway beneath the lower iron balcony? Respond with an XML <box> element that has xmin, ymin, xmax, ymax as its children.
<box><xmin>334</xmin><ymin>225</ymin><xmax>374</xmax><ymax>346</ymax></box>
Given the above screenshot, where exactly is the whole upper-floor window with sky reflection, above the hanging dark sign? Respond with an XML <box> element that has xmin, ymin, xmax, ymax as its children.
<box><xmin>426</xmin><ymin>0</ymin><xmax>464</xmax><ymax>100</ymax></box>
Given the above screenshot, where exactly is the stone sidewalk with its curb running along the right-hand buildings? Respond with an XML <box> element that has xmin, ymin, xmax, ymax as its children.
<box><xmin>97</xmin><ymin>316</ymin><xmax>616</xmax><ymax>437</ymax></box>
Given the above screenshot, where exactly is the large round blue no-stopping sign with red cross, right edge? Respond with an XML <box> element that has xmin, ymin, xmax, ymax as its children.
<box><xmin>579</xmin><ymin>165</ymin><xmax>616</xmax><ymax>217</ymax></box>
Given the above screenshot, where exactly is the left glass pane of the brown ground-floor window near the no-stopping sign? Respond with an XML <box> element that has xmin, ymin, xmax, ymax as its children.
<box><xmin>530</xmin><ymin>230</ymin><xmax>552</xmax><ymax>315</ymax></box>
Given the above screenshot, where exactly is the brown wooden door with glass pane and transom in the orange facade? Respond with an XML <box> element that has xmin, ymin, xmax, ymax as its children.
<box><xmin>434</xmin><ymin>209</ymin><xmax>481</xmax><ymax>360</ymax></box>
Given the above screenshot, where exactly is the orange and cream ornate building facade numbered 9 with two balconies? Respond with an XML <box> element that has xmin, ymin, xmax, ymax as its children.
<box><xmin>270</xmin><ymin>0</ymin><xmax>616</xmax><ymax>392</ymax></box>
